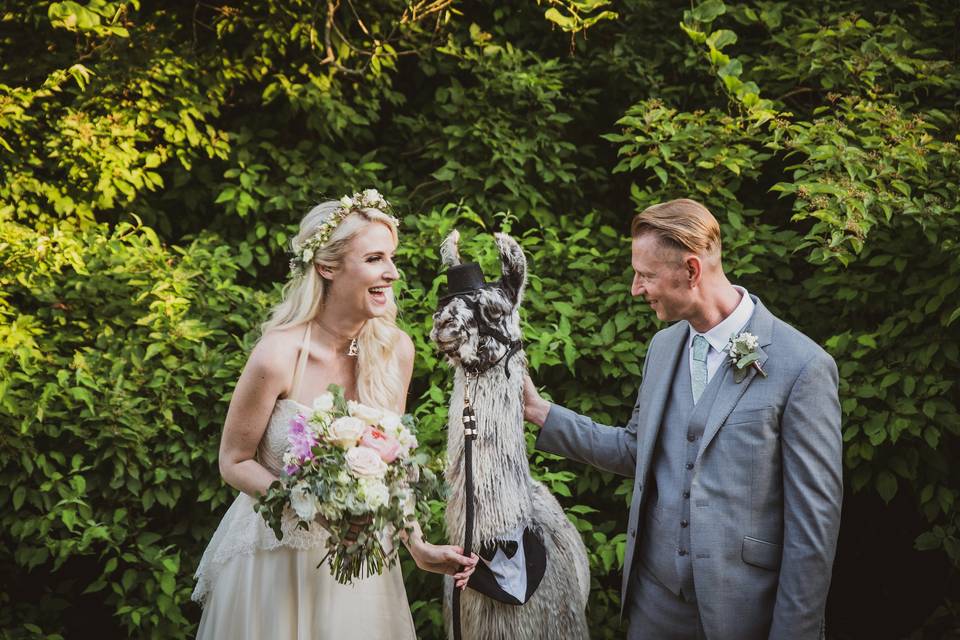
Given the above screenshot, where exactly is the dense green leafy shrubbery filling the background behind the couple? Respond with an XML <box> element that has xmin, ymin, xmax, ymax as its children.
<box><xmin>0</xmin><ymin>0</ymin><xmax>960</xmax><ymax>638</ymax></box>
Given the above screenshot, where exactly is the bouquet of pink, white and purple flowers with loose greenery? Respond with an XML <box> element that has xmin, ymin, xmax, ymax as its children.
<box><xmin>254</xmin><ymin>384</ymin><xmax>435</xmax><ymax>584</ymax></box>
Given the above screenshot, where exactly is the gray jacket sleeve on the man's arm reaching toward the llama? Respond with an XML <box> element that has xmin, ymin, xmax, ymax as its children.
<box><xmin>536</xmin><ymin>338</ymin><xmax>656</xmax><ymax>477</ymax></box>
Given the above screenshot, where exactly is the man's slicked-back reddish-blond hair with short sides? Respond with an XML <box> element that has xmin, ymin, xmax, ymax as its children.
<box><xmin>630</xmin><ymin>198</ymin><xmax>720</xmax><ymax>258</ymax></box>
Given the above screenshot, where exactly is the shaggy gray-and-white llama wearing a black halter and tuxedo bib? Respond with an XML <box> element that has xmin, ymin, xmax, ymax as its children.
<box><xmin>430</xmin><ymin>231</ymin><xmax>590</xmax><ymax>640</ymax></box>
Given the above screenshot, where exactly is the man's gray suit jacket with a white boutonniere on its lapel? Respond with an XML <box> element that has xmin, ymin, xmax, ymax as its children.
<box><xmin>537</xmin><ymin>297</ymin><xmax>843</xmax><ymax>640</ymax></box>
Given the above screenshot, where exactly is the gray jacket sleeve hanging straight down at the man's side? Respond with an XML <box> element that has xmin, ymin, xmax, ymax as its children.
<box><xmin>770</xmin><ymin>351</ymin><xmax>843</xmax><ymax>640</ymax></box>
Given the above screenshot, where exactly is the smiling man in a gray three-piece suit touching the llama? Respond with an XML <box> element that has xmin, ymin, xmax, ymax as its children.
<box><xmin>524</xmin><ymin>200</ymin><xmax>843</xmax><ymax>640</ymax></box>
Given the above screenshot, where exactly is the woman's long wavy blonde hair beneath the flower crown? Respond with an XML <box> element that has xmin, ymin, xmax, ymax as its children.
<box><xmin>260</xmin><ymin>200</ymin><xmax>406</xmax><ymax>411</ymax></box>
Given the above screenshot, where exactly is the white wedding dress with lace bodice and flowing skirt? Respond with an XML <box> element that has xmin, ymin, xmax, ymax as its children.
<box><xmin>192</xmin><ymin>323</ymin><xmax>416</xmax><ymax>640</ymax></box>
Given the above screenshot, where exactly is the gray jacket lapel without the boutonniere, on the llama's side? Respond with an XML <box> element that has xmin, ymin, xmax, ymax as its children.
<box><xmin>637</xmin><ymin>320</ymin><xmax>690</xmax><ymax>478</ymax></box>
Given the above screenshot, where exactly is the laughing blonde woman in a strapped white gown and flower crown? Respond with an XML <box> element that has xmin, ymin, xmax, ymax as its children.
<box><xmin>193</xmin><ymin>189</ymin><xmax>476</xmax><ymax>640</ymax></box>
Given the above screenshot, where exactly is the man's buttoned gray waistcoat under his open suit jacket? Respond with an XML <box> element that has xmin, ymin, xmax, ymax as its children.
<box><xmin>639</xmin><ymin>343</ymin><xmax>724</xmax><ymax>598</ymax></box>
